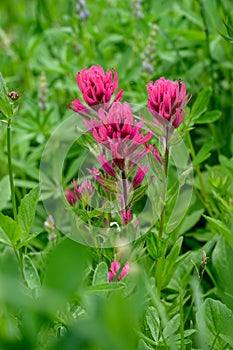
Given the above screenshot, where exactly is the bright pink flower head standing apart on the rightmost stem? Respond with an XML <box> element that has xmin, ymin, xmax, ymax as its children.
<box><xmin>147</xmin><ymin>77</ymin><xmax>191</xmax><ymax>128</ymax></box>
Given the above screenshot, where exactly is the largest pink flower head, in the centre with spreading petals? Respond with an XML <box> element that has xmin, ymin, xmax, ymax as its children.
<box><xmin>85</xmin><ymin>102</ymin><xmax>153</xmax><ymax>173</ymax></box>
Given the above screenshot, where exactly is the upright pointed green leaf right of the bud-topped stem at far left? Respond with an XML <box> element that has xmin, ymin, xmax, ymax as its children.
<box><xmin>18</xmin><ymin>187</ymin><xmax>40</xmax><ymax>240</ymax></box>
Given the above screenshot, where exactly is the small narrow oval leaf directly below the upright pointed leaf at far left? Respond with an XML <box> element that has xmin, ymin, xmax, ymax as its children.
<box><xmin>23</xmin><ymin>255</ymin><xmax>41</xmax><ymax>296</ymax></box>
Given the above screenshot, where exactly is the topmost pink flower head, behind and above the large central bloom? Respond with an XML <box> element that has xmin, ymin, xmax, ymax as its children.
<box><xmin>69</xmin><ymin>65</ymin><xmax>124</xmax><ymax>113</ymax></box>
